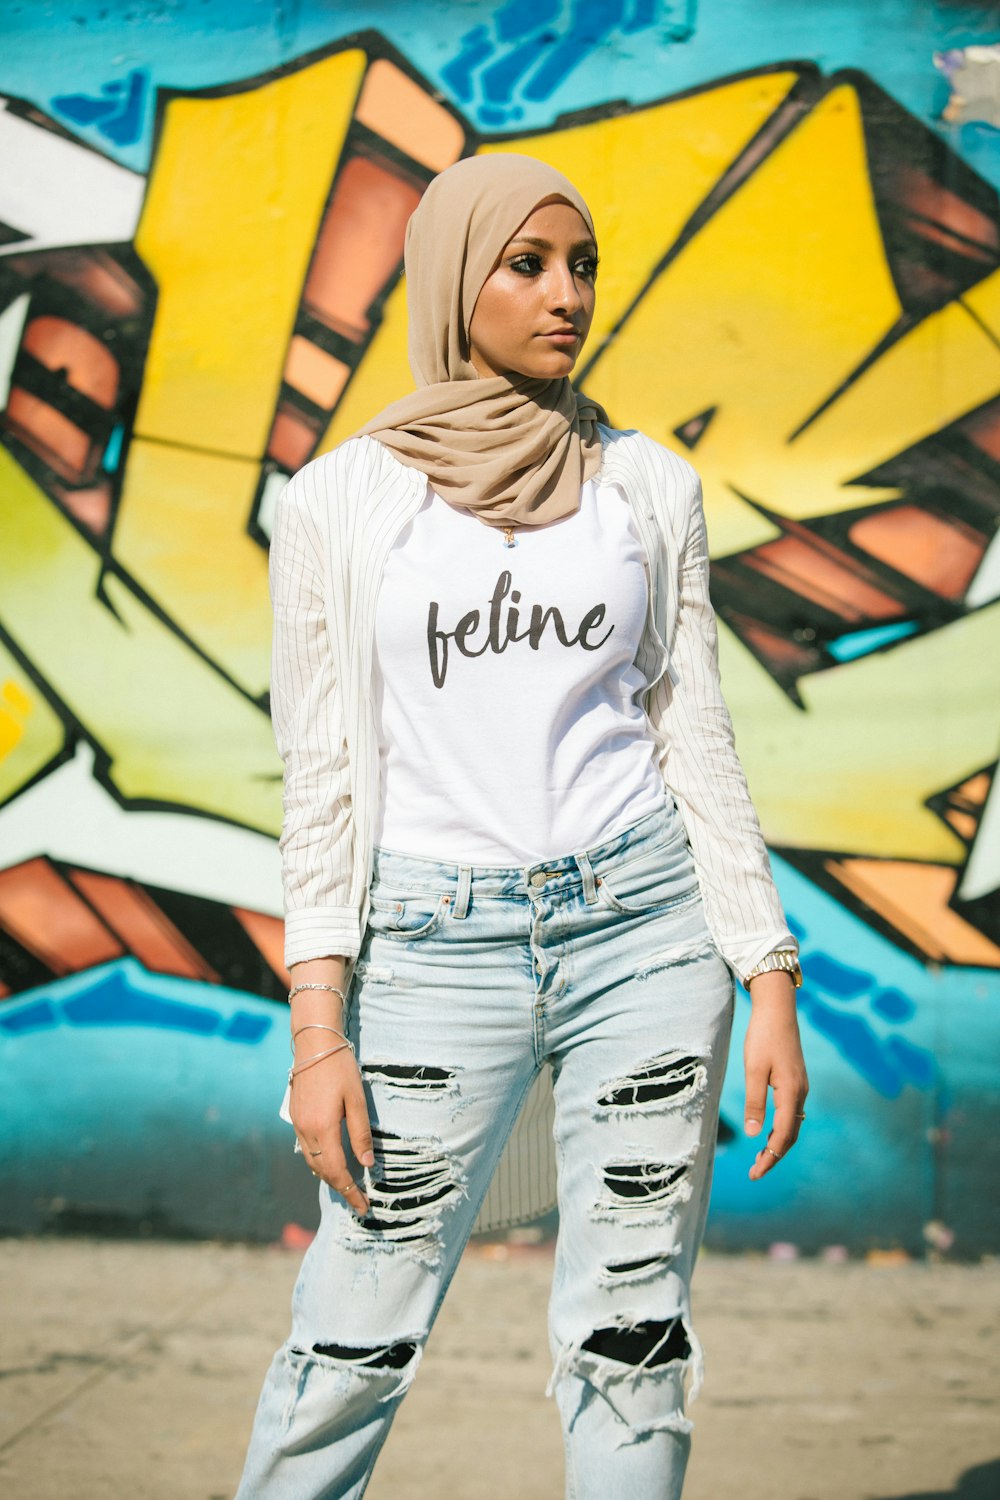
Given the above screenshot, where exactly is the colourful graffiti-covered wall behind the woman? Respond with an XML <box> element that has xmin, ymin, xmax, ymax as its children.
<box><xmin>0</xmin><ymin>0</ymin><xmax>1000</xmax><ymax>1254</ymax></box>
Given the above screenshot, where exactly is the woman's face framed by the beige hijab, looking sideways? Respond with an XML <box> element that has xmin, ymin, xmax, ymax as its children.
<box><xmin>469</xmin><ymin>198</ymin><xmax>597</xmax><ymax>380</ymax></box>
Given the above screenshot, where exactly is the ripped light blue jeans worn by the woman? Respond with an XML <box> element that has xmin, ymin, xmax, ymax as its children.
<box><xmin>237</xmin><ymin>798</ymin><xmax>735</xmax><ymax>1500</ymax></box>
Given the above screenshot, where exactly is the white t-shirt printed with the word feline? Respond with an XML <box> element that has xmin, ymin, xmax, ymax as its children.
<box><xmin>373</xmin><ymin>480</ymin><xmax>666</xmax><ymax>866</ymax></box>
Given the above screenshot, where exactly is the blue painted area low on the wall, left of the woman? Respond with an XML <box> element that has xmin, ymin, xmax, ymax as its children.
<box><xmin>0</xmin><ymin>978</ymin><xmax>295</xmax><ymax>1238</ymax></box>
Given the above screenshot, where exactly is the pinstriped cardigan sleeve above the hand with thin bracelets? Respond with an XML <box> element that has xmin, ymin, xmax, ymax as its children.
<box><xmin>268</xmin><ymin>471</ymin><xmax>360</xmax><ymax>965</ymax></box>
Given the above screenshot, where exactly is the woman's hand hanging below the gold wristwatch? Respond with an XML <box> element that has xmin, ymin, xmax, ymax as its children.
<box><xmin>744</xmin><ymin>969</ymin><xmax>810</xmax><ymax>1182</ymax></box>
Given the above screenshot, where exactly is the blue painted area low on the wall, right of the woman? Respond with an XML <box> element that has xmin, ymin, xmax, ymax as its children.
<box><xmin>708</xmin><ymin>851</ymin><xmax>1000</xmax><ymax>1254</ymax></box>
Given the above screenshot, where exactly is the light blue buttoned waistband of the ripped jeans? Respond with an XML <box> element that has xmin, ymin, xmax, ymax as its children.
<box><xmin>372</xmin><ymin>794</ymin><xmax>684</xmax><ymax>896</ymax></box>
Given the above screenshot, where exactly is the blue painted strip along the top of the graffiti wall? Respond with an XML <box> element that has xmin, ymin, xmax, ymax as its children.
<box><xmin>0</xmin><ymin>0</ymin><xmax>1000</xmax><ymax>196</ymax></box>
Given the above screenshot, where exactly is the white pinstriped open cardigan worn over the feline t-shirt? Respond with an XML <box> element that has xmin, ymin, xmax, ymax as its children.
<box><xmin>268</xmin><ymin>425</ymin><xmax>796</xmax><ymax>1229</ymax></box>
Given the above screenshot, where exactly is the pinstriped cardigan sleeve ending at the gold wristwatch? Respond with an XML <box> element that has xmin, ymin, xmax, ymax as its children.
<box><xmin>651</xmin><ymin>458</ymin><xmax>798</xmax><ymax>978</ymax></box>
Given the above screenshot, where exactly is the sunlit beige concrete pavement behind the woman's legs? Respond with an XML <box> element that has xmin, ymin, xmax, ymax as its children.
<box><xmin>0</xmin><ymin>1239</ymin><xmax>1000</xmax><ymax>1500</ymax></box>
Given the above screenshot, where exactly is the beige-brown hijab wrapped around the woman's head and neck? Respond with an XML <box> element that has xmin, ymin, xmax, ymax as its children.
<box><xmin>352</xmin><ymin>152</ymin><xmax>609</xmax><ymax>527</ymax></box>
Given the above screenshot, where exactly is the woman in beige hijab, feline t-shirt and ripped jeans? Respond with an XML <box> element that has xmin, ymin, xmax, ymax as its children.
<box><xmin>238</xmin><ymin>153</ymin><xmax>807</xmax><ymax>1500</ymax></box>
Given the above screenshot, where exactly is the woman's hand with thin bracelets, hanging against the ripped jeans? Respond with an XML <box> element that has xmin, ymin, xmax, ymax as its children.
<box><xmin>289</xmin><ymin>1031</ymin><xmax>375</xmax><ymax>1218</ymax></box>
